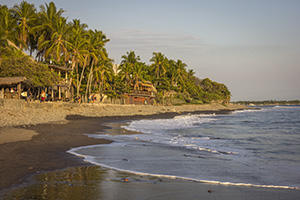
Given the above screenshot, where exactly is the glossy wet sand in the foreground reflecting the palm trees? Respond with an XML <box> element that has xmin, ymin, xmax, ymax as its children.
<box><xmin>0</xmin><ymin>166</ymin><xmax>300</xmax><ymax>200</ymax></box>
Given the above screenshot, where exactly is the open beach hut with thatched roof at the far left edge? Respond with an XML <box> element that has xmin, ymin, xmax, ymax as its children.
<box><xmin>0</xmin><ymin>76</ymin><xmax>27</xmax><ymax>99</ymax></box>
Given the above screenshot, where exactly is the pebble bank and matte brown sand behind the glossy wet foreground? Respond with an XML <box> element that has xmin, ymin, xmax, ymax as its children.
<box><xmin>0</xmin><ymin>104</ymin><xmax>246</xmax><ymax>190</ymax></box>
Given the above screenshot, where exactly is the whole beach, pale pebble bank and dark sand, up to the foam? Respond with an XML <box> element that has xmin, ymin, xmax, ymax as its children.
<box><xmin>0</xmin><ymin>104</ymin><xmax>299</xmax><ymax>199</ymax></box>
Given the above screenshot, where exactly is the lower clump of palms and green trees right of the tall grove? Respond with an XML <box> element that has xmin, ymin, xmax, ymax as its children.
<box><xmin>119</xmin><ymin>51</ymin><xmax>231</xmax><ymax>105</ymax></box>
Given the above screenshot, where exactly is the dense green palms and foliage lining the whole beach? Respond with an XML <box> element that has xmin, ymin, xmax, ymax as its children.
<box><xmin>0</xmin><ymin>1</ymin><xmax>231</xmax><ymax>104</ymax></box>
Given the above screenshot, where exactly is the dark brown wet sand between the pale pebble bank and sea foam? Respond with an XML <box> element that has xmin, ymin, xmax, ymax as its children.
<box><xmin>0</xmin><ymin>111</ymin><xmax>300</xmax><ymax>200</ymax></box>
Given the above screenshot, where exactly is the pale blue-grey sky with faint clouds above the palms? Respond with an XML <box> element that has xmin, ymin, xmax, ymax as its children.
<box><xmin>0</xmin><ymin>0</ymin><xmax>300</xmax><ymax>100</ymax></box>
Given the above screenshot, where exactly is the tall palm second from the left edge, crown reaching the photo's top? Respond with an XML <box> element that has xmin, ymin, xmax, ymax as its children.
<box><xmin>12</xmin><ymin>1</ymin><xmax>37</xmax><ymax>49</ymax></box>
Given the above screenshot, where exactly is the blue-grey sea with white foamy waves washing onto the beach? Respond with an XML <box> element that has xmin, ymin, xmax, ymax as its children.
<box><xmin>69</xmin><ymin>106</ymin><xmax>300</xmax><ymax>189</ymax></box>
